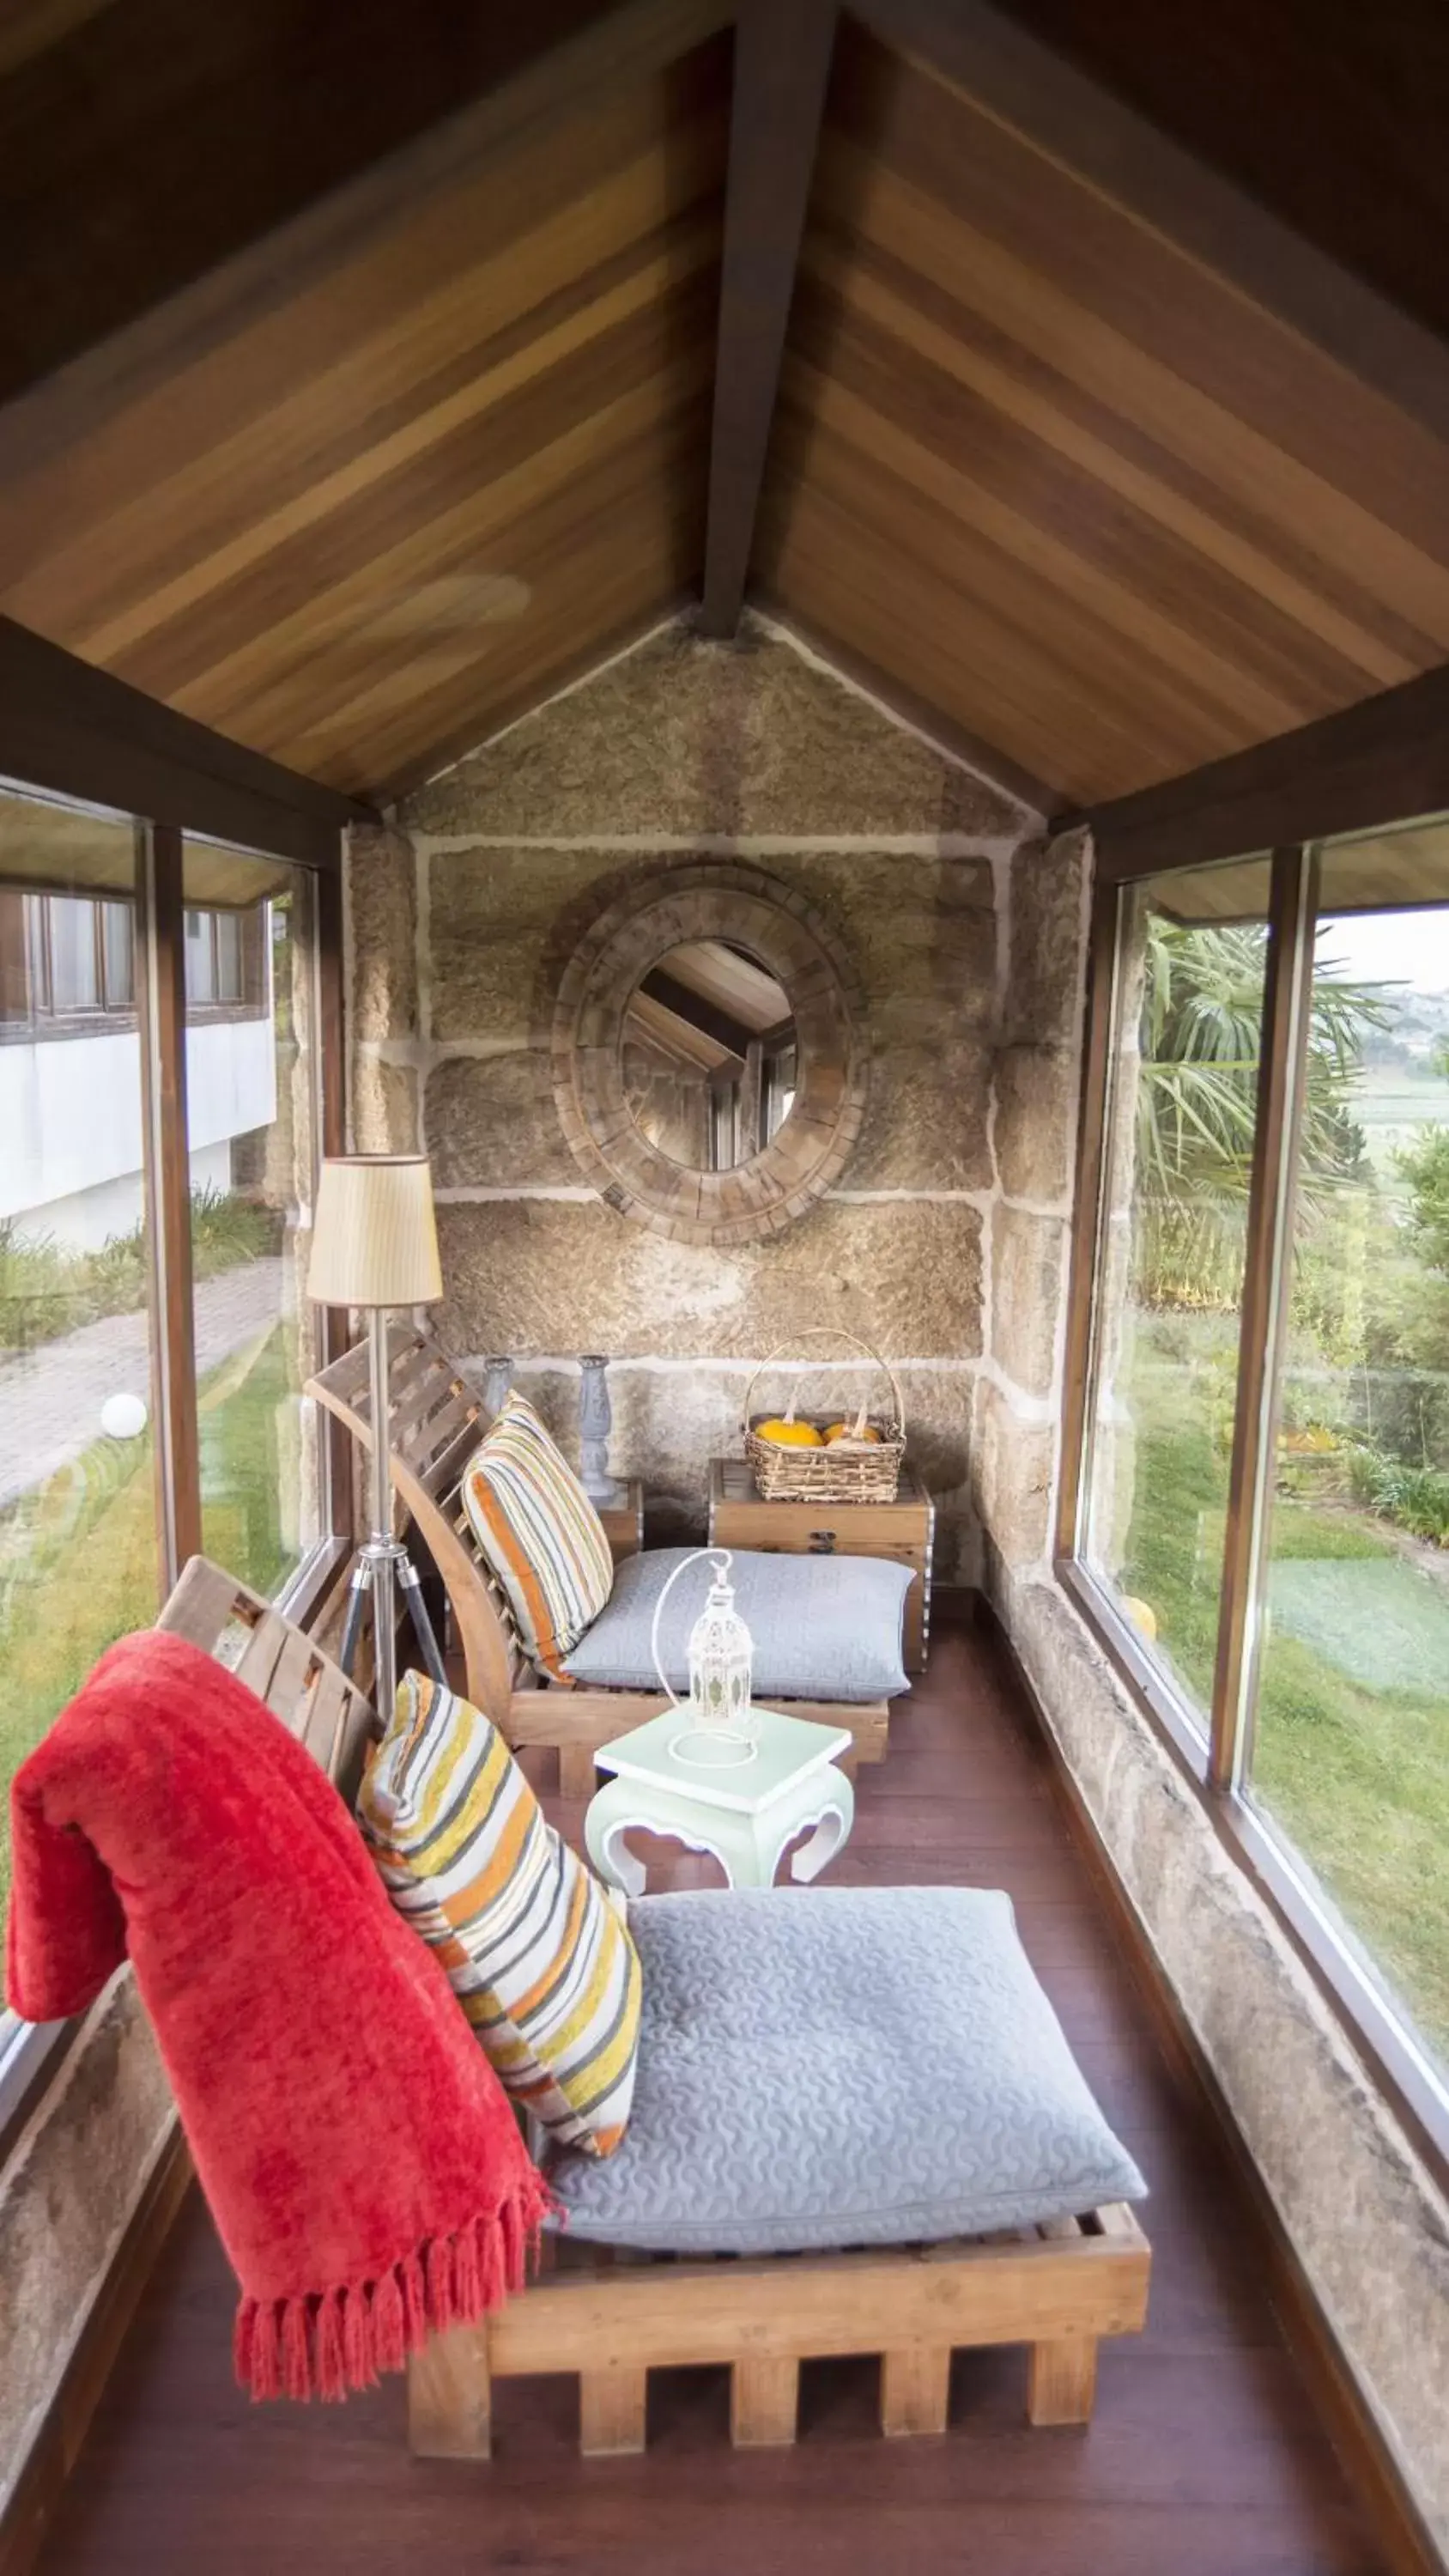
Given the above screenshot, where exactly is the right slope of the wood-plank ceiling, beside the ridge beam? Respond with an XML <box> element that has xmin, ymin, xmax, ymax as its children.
<box><xmin>756</xmin><ymin>26</ymin><xmax>1449</xmax><ymax>804</ymax></box>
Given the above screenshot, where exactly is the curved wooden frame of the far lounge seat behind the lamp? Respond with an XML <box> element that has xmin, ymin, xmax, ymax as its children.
<box><xmin>306</xmin><ymin>1327</ymin><xmax>890</xmax><ymax>1798</ymax></box>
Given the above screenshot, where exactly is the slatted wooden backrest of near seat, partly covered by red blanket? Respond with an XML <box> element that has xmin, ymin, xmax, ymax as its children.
<box><xmin>157</xmin><ymin>1556</ymin><xmax>376</xmax><ymax>1803</ymax></box>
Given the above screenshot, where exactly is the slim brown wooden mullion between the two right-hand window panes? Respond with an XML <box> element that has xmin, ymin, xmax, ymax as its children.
<box><xmin>1207</xmin><ymin>848</ymin><xmax>1318</xmax><ymax>1790</ymax></box>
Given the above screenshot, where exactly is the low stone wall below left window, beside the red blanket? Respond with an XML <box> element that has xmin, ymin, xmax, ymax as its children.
<box><xmin>0</xmin><ymin>1968</ymin><xmax>173</xmax><ymax>2512</ymax></box>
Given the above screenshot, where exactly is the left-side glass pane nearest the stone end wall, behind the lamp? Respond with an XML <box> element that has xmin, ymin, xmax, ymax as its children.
<box><xmin>185</xmin><ymin>840</ymin><xmax>324</xmax><ymax>1592</ymax></box>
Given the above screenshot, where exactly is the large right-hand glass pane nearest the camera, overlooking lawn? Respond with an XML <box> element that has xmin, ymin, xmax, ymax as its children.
<box><xmin>1251</xmin><ymin>871</ymin><xmax>1449</xmax><ymax>2071</ymax></box>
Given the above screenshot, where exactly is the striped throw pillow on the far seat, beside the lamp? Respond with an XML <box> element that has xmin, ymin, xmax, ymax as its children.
<box><xmin>464</xmin><ymin>1394</ymin><xmax>613</xmax><ymax>1682</ymax></box>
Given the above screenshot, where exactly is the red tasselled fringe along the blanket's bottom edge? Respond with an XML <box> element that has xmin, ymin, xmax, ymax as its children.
<box><xmin>232</xmin><ymin>2187</ymin><xmax>546</xmax><ymax>2401</ymax></box>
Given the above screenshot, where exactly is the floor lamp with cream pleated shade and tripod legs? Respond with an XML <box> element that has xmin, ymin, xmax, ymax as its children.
<box><xmin>306</xmin><ymin>1154</ymin><xmax>446</xmax><ymax>1726</ymax></box>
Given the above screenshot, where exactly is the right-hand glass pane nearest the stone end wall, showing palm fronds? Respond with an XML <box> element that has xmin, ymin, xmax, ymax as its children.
<box><xmin>1083</xmin><ymin>860</ymin><xmax>1266</xmax><ymax>1728</ymax></box>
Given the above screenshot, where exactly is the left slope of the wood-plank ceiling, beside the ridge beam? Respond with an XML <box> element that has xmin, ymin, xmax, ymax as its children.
<box><xmin>0</xmin><ymin>0</ymin><xmax>728</xmax><ymax>791</ymax></box>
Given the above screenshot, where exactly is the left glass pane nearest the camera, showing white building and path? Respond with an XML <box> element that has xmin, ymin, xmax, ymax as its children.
<box><xmin>0</xmin><ymin>796</ymin><xmax>160</xmax><ymax>1909</ymax></box>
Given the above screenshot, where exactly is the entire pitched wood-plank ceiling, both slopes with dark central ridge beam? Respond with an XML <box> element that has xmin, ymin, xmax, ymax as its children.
<box><xmin>0</xmin><ymin>0</ymin><xmax>1449</xmax><ymax>809</ymax></box>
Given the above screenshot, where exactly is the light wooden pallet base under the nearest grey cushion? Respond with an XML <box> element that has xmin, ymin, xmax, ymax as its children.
<box><xmin>409</xmin><ymin>2202</ymin><xmax>1150</xmax><ymax>2460</ymax></box>
